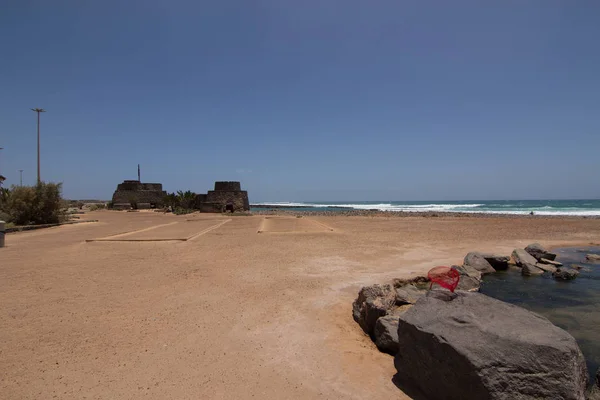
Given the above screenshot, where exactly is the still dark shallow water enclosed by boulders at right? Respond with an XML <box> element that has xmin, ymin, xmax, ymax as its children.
<box><xmin>481</xmin><ymin>247</ymin><xmax>600</xmax><ymax>382</ymax></box>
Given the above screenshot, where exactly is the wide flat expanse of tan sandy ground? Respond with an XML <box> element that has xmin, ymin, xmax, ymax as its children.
<box><xmin>0</xmin><ymin>211</ymin><xmax>600</xmax><ymax>399</ymax></box>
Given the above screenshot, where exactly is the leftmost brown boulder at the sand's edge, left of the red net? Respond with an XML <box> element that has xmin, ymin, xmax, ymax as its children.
<box><xmin>352</xmin><ymin>285</ymin><xmax>396</xmax><ymax>336</ymax></box>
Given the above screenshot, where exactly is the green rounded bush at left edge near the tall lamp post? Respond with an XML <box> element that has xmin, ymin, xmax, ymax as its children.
<box><xmin>2</xmin><ymin>182</ymin><xmax>64</xmax><ymax>225</ymax></box>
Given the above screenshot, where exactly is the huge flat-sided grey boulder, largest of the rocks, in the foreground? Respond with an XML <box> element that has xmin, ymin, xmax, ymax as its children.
<box><xmin>395</xmin><ymin>291</ymin><xmax>587</xmax><ymax>400</ymax></box>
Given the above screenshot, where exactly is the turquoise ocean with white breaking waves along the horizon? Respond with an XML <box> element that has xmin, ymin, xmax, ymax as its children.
<box><xmin>253</xmin><ymin>200</ymin><xmax>600</xmax><ymax>216</ymax></box>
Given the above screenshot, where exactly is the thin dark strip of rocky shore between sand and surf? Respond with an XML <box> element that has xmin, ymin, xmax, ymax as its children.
<box><xmin>250</xmin><ymin>206</ymin><xmax>600</xmax><ymax>219</ymax></box>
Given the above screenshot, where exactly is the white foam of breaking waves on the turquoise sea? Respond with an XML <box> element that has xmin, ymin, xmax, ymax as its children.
<box><xmin>256</xmin><ymin>202</ymin><xmax>600</xmax><ymax>216</ymax></box>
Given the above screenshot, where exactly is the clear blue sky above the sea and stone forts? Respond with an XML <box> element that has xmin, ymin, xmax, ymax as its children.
<box><xmin>0</xmin><ymin>0</ymin><xmax>600</xmax><ymax>201</ymax></box>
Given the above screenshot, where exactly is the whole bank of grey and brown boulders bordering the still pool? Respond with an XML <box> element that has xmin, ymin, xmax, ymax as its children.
<box><xmin>352</xmin><ymin>243</ymin><xmax>600</xmax><ymax>400</ymax></box>
